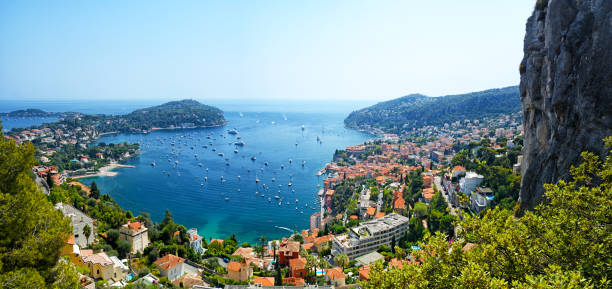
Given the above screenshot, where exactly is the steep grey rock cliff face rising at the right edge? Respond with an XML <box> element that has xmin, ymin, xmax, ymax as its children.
<box><xmin>519</xmin><ymin>0</ymin><xmax>612</xmax><ymax>210</ymax></box>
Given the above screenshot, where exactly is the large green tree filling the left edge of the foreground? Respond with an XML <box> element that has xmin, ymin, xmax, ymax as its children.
<box><xmin>0</xmin><ymin>125</ymin><xmax>76</xmax><ymax>288</ymax></box>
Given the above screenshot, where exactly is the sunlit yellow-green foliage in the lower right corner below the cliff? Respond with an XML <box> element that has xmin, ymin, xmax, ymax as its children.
<box><xmin>362</xmin><ymin>137</ymin><xmax>612</xmax><ymax>289</ymax></box>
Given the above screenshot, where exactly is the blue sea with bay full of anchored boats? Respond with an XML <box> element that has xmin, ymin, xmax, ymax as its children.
<box><xmin>0</xmin><ymin>100</ymin><xmax>374</xmax><ymax>243</ymax></box>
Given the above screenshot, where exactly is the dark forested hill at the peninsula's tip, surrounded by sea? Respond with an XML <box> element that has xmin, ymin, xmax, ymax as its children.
<box><xmin>121</xmin><ymin>99</ymin><xmax>225</xmax><ymax>129</ymax></box>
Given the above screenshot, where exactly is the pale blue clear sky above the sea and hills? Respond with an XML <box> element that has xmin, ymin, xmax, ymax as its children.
<box><xmin>0</xmin><ymin>0</ymin><xmax>535</xmax><ymax>103</ymax></box>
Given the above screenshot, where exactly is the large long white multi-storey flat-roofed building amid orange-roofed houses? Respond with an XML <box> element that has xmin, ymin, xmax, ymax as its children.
<box><xmin>332</xmin><ymin>213</ymin><xmax>409</xmax><ymax>260</ymax></box>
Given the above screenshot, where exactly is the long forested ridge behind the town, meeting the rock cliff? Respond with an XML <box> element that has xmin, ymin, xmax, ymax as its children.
<box><xmin>344</xmin><ymin>86</ymin><xmax>521</xmax><ymax>134</ymax></box>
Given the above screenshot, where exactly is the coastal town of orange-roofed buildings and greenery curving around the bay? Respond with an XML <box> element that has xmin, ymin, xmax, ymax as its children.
<box><xmin>5</xmin><ymin>102</ymin><xmax>522</xmax><ymax>288</ymax></box>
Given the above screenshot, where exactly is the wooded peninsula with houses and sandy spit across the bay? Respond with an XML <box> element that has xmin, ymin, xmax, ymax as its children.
<box><xmin>3</xmin><ymin>100</ymin><xmax>226</xmax><ymax>177</ymax></box>
